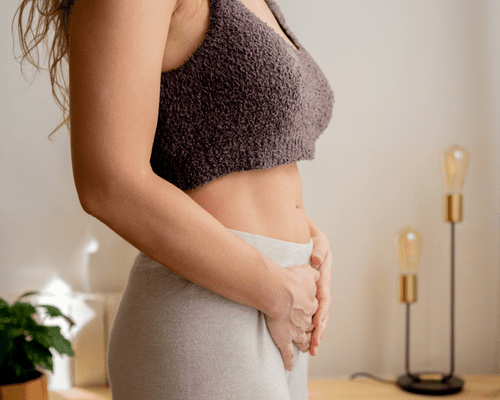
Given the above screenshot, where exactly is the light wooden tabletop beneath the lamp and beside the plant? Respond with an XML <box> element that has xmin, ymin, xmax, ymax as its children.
<box><xmin>49</xmin><ymin>375</ymin><xmax>500</xmax><ymax>400</ymax></box>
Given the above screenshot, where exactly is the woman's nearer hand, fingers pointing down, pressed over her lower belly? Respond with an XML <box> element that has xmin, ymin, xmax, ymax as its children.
<box><xmin>264</xmin><ymin>264</ymin><xmax>320</xmax><ymax>371</ymax></box>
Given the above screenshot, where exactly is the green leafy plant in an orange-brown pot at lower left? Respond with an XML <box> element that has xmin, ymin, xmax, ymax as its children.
<box><xmin>0</xmin><ymin>292</ymin><xmax>75</xmax><ymax>400</ymax></box>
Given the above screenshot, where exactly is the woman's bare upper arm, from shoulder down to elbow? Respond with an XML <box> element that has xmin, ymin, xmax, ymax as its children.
<box><xmin>69</xmin><ymin>0</ymin><xmax>177</xmax><ymax>208</ymax></box>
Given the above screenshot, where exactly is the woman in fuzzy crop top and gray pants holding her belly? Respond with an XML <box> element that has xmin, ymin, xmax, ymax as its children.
<box><xmin>12</xmin><ymin>0</ymin><xmax>333</xmax><ymax>400</ymax></box>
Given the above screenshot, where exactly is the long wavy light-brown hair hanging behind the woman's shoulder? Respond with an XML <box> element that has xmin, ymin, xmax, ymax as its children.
<box><xmin>11</xmin><ymin>0</ymin><xmax>75</xmax><ymax>139</ymax></box>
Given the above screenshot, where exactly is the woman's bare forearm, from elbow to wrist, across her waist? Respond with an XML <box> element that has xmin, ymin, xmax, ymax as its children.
<box><xmin>82</xmin><ymin>173</ymin><xmax>292</xmax><ymax>315</ymax></box>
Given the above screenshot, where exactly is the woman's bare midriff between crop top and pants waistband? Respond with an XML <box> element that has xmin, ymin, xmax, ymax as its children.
<box><xmin>182</xmin><ymin>163</ymin><xmax>311</xmax><ymax>243</ymax></box>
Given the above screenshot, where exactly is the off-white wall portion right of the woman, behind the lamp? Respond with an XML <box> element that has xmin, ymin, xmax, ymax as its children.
<box><xmin>286</xmin><ymin>0</ymin><xmax>500</xmax><ymax>377</ymax></box>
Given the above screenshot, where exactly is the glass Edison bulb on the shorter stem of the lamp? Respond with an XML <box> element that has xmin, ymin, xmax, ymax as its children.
<box><xmin>396</xmin><ymin>226</ymin><xmax>422</xmax><ymax>274</ymax></box>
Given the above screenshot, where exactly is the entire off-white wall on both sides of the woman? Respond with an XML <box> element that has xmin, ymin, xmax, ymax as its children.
<box><xmin>0</xmin><ymin>0</ymin><xmax>500</xmax><ymax>378</ymax></box>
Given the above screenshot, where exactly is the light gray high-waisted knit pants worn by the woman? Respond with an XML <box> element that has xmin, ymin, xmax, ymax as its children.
<box><xmin>107</xmin><ymin>230</ymin><xmax>313</xmax><ymax>400</ymax></box>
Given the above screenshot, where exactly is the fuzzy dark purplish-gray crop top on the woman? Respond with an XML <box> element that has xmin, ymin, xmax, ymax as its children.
<box><xmin>150</xmin><ymin>0</ymin><xmax>333</xmax><ymax>190</ymax></box>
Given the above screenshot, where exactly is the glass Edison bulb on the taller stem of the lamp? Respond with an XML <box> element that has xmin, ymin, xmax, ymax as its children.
<box><xmin>442</xmin><ymin>144</ymin><xmax>469</xmax><ymax>193</ymax></box>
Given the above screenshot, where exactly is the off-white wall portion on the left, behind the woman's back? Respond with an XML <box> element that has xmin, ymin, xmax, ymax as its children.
<box><xmin>0</xmin><ymin>0</ymin><xmax>137</xmax><ymax>300</ymax></box>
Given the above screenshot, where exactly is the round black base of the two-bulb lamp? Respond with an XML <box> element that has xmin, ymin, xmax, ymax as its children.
<box><xmin>396</xmin><ymin>372</ymin><xmax>464</xmax><ymax>396</ymax></box>
